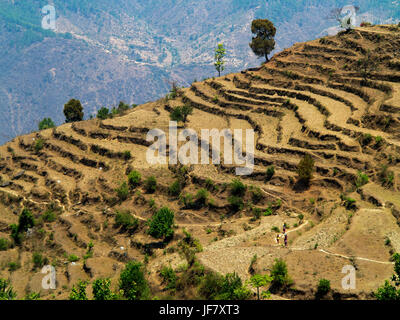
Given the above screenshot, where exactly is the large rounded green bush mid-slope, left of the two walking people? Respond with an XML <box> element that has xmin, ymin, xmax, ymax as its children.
<box><xmin>149</xmin><ymin>207</ymin><xmax>174</xmax><ymax>239</ymax></box>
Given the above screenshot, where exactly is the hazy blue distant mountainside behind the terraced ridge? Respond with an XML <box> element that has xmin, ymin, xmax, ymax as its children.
<box><xmin>0</xmin><ymin>0</ymin><xmax>400</xmax><ymax>143</ymax></box>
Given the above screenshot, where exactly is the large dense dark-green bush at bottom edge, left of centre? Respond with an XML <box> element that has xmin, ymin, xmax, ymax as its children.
<box><xmin>119</xmin><ymin>261</ymin><xmax>149</xmax><ymax>300</ymax></box>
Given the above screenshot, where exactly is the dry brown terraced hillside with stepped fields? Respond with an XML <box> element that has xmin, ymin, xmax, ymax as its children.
<box><xmin>0</xmin><ymin>25</ymin><xmax>400</xmax><ymax>299</ymax></box>
